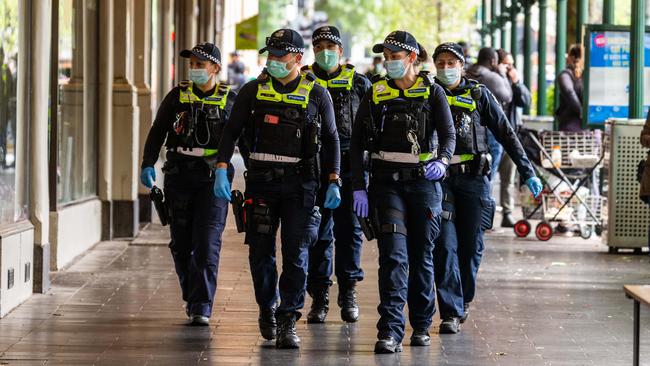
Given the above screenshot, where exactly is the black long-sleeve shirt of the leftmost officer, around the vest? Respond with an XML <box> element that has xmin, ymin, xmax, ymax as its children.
<box><xmin>141</xmin><ymin>85</ymin><xmax>237</xmax><ymax>168</ymax></box>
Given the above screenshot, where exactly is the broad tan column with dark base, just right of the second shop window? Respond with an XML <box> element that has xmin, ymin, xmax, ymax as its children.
<box><xmin>112</xmin><ymin>0</ymin><xmax>140</xmax><ymax>237</ymax></box>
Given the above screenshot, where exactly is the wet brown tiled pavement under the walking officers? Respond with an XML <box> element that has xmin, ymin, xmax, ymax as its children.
<box><xmin>0</xmin><ymin>161</ymin><xmax>650</xmax><ymax>366</ymax></box>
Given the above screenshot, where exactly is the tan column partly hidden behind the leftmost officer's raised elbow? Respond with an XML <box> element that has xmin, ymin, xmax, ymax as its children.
<box><xmin>133</xmin><ymin>0</ymin><xmax>153</xmax><ymax>222</ymax></box>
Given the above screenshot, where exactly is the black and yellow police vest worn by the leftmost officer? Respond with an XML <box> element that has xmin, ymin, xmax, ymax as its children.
<box><xmin>173</xmin><ymin>81</ymin><xmax>230</xmax><ymax>156</ymax></box>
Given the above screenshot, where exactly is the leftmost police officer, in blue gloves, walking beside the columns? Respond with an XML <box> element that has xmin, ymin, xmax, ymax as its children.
<box><xmin>140</xmin><ymin>43</ymin><xmax>235</xmax><ymax>325</ymax></box>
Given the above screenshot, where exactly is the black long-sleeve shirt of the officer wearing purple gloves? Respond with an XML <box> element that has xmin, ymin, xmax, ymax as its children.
<box><xmin>350</xmin><ymin>79</ymin><xmax>456</xmax><ymax>190</ymax></box>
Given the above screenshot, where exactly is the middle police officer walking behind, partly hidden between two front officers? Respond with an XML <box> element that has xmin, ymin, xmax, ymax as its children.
<box><xmin>303</xmin><ymin>26</ymin><xmax>370</xmax><ymax>323</ymax></box>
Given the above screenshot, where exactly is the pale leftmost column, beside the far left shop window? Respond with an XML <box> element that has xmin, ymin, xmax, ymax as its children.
<box><xmin>29</xmin><ymin>1</ymin><xmax>52</xmax><ymax>293</ymax></box>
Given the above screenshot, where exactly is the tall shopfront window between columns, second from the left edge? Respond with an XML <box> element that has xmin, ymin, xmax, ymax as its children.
<box><xmin>56</xmin><ymin>0</ymin><xmax>98</xmax><ymax>204</ymax></box>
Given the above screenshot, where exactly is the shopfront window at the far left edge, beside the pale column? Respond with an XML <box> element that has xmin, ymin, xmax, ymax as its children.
<box><xmin>0</xmin><ymin>0</ymin><xmax>27</xmax><ymax>225</ymax></box>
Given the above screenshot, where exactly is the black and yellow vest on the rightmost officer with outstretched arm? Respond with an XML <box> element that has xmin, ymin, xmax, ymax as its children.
<box><xmin>446</xmin><ymin>80</ymin><xmax>489</xmax><ymax>160</ymax></box>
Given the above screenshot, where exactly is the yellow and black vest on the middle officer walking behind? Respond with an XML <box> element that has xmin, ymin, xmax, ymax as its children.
<box><xmin>303</xmin><ymin>64</ymin><xmax>361</xmax><ymax>151</ymax></box>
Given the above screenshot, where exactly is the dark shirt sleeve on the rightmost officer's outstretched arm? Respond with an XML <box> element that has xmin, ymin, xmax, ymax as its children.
<box><xmin>438</xmin><ymin>78</ymin><xmax>535</xmax><ymax>180</ymax></box>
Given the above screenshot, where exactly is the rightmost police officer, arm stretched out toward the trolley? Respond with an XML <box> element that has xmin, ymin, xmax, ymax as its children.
<box><xmin>433</xmin><ymin>43</ymin><xmax>542</xmax><ymax>333</ymax></box>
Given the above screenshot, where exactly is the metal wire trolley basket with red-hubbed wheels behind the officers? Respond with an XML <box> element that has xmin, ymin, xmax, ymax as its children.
<box><xmin>514</xmin><ymin>130</ymin><xmax>606</xmax><ymax>241</ymax></box>
